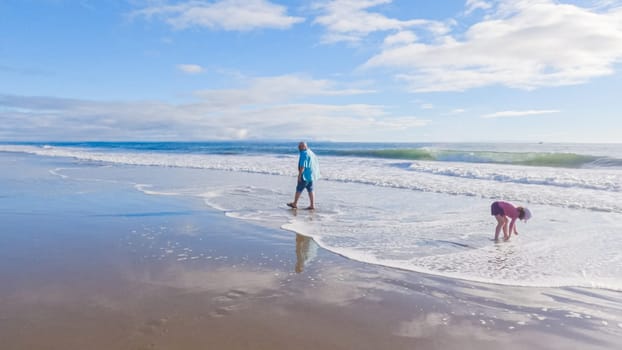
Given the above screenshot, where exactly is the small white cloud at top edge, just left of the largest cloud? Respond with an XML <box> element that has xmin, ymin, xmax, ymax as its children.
<box><xmin>313</xmin><ymin>0</ymin><xmax>449</xmax><ymax>43</ymax></box>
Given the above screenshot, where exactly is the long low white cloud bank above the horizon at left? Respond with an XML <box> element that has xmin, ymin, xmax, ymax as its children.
<box><xmin>0</xmin><ymin>75</ymin><xmax>428</xmax><ymax>141</ymax></box>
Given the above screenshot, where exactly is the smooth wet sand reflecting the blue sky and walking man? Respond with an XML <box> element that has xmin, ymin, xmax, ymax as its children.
<box><xmin>0</xmin><ymin>154</ymin><xmax>622</xmax><ymax>349</ymax></box>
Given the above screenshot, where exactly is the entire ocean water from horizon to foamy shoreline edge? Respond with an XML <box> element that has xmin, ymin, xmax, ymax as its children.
<box><xmin>0</xmin><ymin>142</ymin><xmax>622</xmax><ymax>290</ymax></box>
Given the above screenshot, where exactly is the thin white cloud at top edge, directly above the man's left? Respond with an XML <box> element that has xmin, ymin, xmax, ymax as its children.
<box><xmin>133</xmin><ymin>0</ymin><xmax>304</xmax><ymax>31</ymax></box>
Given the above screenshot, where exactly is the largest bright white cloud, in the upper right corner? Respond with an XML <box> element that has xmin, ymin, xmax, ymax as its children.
<box><xmin>363</xmin><ymin>0</ymin><xmax>622</xmax><ymax>92</ymax></box>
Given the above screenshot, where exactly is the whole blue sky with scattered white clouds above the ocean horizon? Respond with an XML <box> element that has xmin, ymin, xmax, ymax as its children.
<box><xmin>0</xmin><ymin>0</ymin><xmax>622</xmax><ymax>142</ymax></box>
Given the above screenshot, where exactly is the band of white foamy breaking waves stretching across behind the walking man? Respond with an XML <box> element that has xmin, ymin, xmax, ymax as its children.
<box><xmin>0</xmin><ymin>145</ymin><xmax>622</xmax><ymax>213</ymax></box>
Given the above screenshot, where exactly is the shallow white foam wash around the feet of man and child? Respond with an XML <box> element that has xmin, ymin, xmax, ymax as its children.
<box><xmin>207</xmin><ymin>179</ymin><xmax>622</xmax><ymax>290</ymax></box>
